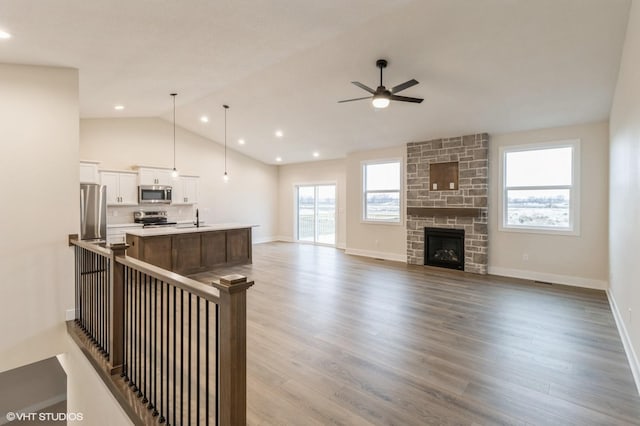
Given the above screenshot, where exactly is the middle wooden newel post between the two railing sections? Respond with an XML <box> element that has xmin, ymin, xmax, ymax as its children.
<box><xmin>109</xmin><ymin>244</ymin><xmax>129</xmax><ymax>374</ymax></box>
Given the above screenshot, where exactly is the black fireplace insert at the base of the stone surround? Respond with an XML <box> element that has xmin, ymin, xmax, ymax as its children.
<box><xmin>424</xmin><ymin>228</ymin><xmax>464</xmax><ymax>271</ymax></box>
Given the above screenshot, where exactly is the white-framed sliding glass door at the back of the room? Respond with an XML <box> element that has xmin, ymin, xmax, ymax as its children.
<box><xmin>296</xmin><ymin>185</ymin><xmax>336</xmax><ymax>245</ymax></box>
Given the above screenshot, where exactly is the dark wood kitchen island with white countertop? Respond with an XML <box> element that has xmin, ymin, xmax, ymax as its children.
<box><xmin>126</xmin><ymin>223</ymin><xmax>255</xmax><ymax>275</ymax></box>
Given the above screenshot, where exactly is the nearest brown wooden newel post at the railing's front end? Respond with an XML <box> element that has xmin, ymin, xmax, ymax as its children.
<box><xmin>216</xmin><ymin>275</ymin><xmax>253</xmax><ymax>425</ymax></box>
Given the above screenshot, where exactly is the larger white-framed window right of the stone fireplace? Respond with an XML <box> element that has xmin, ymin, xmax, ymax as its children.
<box><xmin>501</xmin><ymin>140</ymin><xmax>580</xmax><ymax>235</ymax></box>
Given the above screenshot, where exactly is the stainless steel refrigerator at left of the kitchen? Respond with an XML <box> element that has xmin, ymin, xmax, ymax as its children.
<box><xmin>80</xmin><ymin>183</ymin><xmax>107</xmax><ymax>242</ymax></box>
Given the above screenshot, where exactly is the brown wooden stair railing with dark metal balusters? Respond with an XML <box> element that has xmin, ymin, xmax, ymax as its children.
<box><xmin>67</xmin><ymin>236</ymin><xmax>253</xmax><ymax>425</ymax></box>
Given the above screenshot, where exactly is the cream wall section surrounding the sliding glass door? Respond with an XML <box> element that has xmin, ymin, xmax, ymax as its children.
<box><xmin>278</xmin><ymin>160</ymin><xmax>347</xmax><ymax>248</ymax></box>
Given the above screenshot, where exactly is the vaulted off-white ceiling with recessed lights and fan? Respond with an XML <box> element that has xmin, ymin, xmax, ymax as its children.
<box><xmin>0</xmin><ymin>0</ymin><xmax>630</xmax><ymax>164</ymax></box>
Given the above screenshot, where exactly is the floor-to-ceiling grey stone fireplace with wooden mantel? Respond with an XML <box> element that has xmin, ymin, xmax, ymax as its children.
<box><xmin>407</xmin><ymin>133</ymin><xmax>489</xmax><ymax>274</ymax></box>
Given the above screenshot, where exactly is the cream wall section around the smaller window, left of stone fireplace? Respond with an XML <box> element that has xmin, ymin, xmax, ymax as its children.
<box><xmin>346</xmin><ymin>145</ymin><xmax>407</xmax><ymax>262</ymax></box>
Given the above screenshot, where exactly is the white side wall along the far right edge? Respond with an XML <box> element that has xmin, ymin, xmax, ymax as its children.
<box><xmin>609</xmin><ymin>0</ymin><xmax>640</xmax><ymax>388</ymax></box>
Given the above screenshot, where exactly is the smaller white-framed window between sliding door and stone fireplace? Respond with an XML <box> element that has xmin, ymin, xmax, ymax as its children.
<box><xmin>362</xmin><ymin>160</ymin><xmax>401</xmax><ymax>223</ymax></box>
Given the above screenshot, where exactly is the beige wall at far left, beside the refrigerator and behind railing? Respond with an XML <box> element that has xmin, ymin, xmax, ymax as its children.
<box><xmin>0</xmin><ymin>64</ymin><xmax>79</xmax><ymax>371</ymax></box>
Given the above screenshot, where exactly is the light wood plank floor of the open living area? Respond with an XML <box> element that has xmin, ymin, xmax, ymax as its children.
<box><xmin>194</xmin><ymin>243</ymin><xmax>640</xmax><ymax>425</ymax></box>
